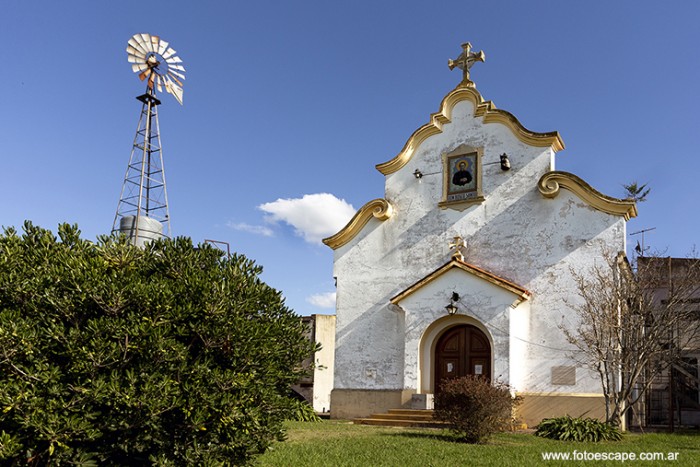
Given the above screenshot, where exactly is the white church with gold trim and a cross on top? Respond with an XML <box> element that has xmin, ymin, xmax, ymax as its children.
<box><xmin>324</xmin><ymin>44</ymin><xmax>637</xmax><ymax>425</ymax></box>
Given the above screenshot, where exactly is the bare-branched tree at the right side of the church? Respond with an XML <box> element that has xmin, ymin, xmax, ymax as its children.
<box><xmin>560</xmin><ymin>252</ymin><xmax>700</xmax><ymax>425</ymax></box>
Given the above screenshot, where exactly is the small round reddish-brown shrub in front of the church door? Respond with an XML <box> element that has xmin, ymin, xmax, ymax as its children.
<box><xmin>433</xmin><ymin>376</ymin><xmax>520</xmax><ymax>443</ymax></box>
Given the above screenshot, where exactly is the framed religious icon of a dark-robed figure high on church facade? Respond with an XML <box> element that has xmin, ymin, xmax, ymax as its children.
<box><xmin>439</xmin><ymin>145</ymin><xmax>484</xmax><ymax>210</ymax></box>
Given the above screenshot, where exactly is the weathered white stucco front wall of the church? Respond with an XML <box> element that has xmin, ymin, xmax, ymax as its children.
<box><xmin>334</xmin><ymin>94</ymin><xmax>625</xmax><ymax>393</ymax></box>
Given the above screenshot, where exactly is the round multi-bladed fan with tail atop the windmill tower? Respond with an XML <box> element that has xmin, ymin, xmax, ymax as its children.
<box><xmin>126</xmin><ymin>34</ymin><xmax>185</xmax><ymax>104</ymax></box>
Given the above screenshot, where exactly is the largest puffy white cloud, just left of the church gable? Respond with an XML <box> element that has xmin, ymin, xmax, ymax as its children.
<box><xmin>258</xmin><ymin>193</ymin><xmax>355</xmax><ymax>243</ymax></box>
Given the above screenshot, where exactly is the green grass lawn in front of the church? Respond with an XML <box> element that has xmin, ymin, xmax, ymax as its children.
<box><xmin>256</xmin><ymin>420</ymin><xmax>700</xmax><ymax>467</ymax></box>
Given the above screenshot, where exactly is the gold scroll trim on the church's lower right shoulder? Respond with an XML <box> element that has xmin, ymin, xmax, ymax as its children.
<box><xmin>537</xmin><ymin>171</ymin><xmax>637</xmax><ymax>221</ymax></box>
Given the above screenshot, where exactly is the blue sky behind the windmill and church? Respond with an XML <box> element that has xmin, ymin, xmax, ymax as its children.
<box><xmin>0</xmin><ymin>0</ymin><xmax>700</xmax><ymax>314</ymax></box>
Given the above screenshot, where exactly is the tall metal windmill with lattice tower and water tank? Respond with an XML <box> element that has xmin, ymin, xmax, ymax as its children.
<box><xmin>112</xmin><ymin>34</ymin><xmax>185</xmax><ymax>246</ymax></box>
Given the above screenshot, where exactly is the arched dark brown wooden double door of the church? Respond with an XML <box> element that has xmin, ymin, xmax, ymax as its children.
<box><xmin>434</xmin><ymin>324</ymin><xmax>491</xmax><ymax>393</ymax></box>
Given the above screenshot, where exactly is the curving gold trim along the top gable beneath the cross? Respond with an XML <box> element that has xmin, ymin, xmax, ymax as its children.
<box><xmin>376</xmin><ymin>86</ymin><xmax>564</xmax><ymax>175</ymax></box>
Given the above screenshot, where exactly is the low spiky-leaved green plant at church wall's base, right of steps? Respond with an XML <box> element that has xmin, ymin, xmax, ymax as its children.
<box><xmin>535</xmin><ymin>415</ymin><xmax>622</xmax><ymax>442</ymax></box>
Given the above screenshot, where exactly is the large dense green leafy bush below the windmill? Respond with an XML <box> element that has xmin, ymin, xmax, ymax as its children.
<box><xmin>0</xmin><ymin>223</ymin><xmax>313</xmax><ymax>465</ymax></box>
